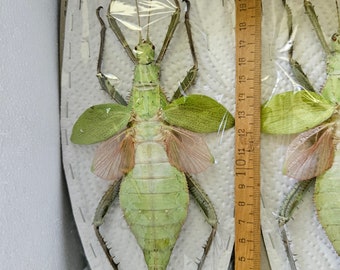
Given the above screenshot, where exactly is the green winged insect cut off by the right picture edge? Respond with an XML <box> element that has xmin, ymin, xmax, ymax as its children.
<box><xmin>262</xmin><ymin>0</ymin><xmax>340</xmax><ymax>255</ymax></box>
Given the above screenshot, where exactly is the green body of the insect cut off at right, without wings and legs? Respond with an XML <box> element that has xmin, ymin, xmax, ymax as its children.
<box><xmin>314</xmin><ymin>33</ymin><xmax>340</xmax><ymax>255</ymax></box>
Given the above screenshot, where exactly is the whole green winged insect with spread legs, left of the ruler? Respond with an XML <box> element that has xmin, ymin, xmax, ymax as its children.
<box><xmin>71</xmin><ymin>0</ymin><xmax>234</xmax><ymax>270</ymax></box>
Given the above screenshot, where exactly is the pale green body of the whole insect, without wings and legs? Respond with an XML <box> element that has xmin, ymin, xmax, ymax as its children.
<box><xmin>113</xmin><ymin>51</ymin><xmax>189</xmax><ymax>269</ymax></box>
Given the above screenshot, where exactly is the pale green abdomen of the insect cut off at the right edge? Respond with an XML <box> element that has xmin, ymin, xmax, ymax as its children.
<box><xmin>314</xmin><ymin>117</ymin><xmax>340</xmax><ymax>255</ymax></box>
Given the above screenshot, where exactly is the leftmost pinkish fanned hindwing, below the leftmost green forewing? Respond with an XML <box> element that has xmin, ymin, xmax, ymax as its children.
<box><xmin>92</xmin><ymin>129</ymin><xmax>135</xmax><ymax>180</ymax></box>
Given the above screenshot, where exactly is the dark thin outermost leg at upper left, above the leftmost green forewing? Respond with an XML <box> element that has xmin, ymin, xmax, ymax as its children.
<box><xmin>96</xmin><ymin>7</ymin><xmax>127</xmax><ymax>105</ymax></box>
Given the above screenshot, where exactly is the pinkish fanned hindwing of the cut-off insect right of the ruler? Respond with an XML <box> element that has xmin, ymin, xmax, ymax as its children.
<box><xmin>283</xmin><ymin>124</ymin><xmax>334</xmax><ymax>180</ymax></box>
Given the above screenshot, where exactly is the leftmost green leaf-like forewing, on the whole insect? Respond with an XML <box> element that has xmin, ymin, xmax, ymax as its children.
<box><xmin>71</xmin><ymin>104</ymin><xmax>131</xmax><ymax>144</ymax></box>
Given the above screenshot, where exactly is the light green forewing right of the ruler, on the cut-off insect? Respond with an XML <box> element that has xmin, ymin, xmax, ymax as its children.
<box><xmin>261</xmin><ymin>90</ymin><xmax>335</xmax><ymax>134</ymax></box>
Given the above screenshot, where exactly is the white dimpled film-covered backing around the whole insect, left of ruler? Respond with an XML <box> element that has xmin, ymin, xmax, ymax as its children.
<box><xmin>61</xmin><ymin>0</ymin><xmax>235</xmax><ymax>270</ymax></box>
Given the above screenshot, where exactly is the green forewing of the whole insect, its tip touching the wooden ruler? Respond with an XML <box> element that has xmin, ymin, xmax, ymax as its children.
<box><xmin>162</xmin><ymin>95</ymin><xmax>234</xmax><ymax>133</ymax></box>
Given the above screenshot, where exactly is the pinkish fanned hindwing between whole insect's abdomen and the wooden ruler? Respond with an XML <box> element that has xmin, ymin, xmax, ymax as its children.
<box><xmin>164</xmin><ymin>127</ymin><xmax>214</xmax><ymax>174</ymax></box>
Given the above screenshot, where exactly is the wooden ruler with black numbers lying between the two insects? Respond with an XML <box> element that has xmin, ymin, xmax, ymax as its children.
<box><xmin>235</xmin><ymin>0</ymin><xmax>261</xmax><ymax>270</ymax></box>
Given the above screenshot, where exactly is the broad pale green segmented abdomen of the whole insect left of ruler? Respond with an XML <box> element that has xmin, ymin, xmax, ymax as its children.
<box><xmin>120</xmin><ymin>142</ymin><xmax>189</xmax><ymax>270</ymax></box>
